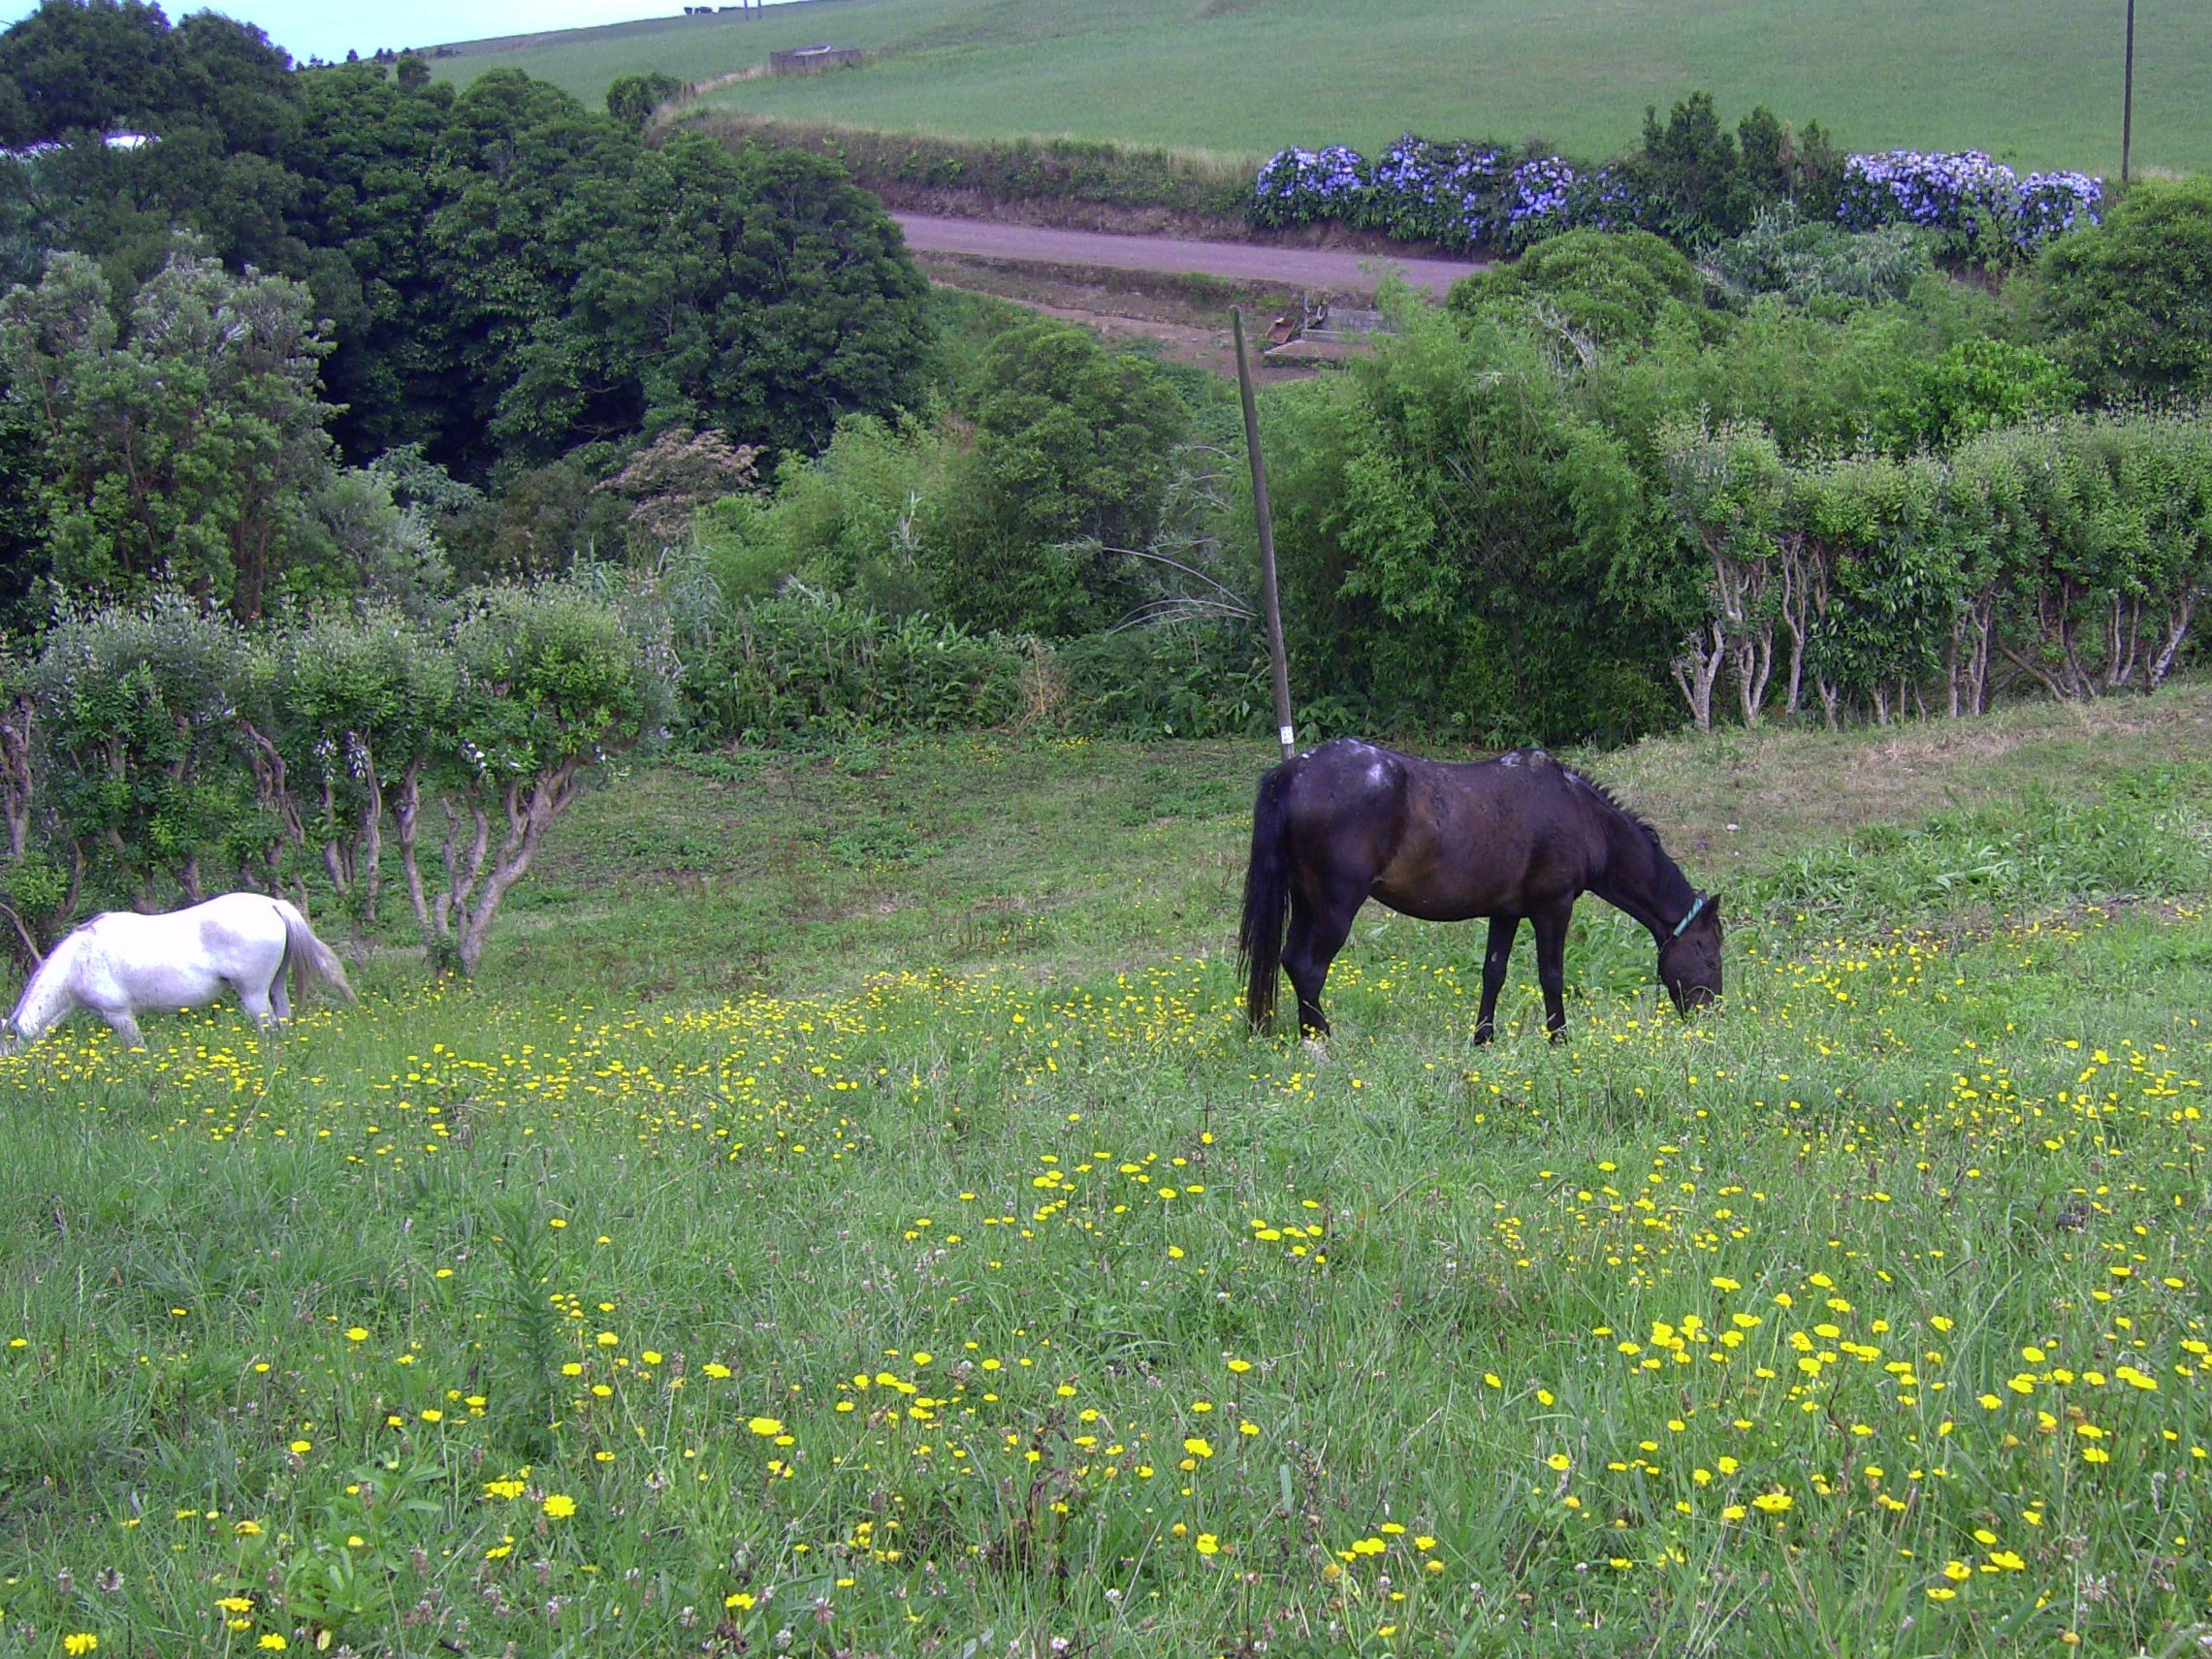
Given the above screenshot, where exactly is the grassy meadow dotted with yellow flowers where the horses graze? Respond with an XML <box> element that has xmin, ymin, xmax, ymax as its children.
<box><xmin>0</xmin><ymin>687</ymin><xmax>2212</xmax><ymax>1654</ymax></box>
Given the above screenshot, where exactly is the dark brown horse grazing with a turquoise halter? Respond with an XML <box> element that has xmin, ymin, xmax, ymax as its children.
<box><xmin>1236</xmin><ymin>737</ymin><xmax>1721</xmax><ymax>1042</ymax></box>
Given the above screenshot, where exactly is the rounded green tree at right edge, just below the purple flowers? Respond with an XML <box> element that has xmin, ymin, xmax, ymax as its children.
<box><xmin>2039</xmin><ymin>179</ymin><xmax>2212</xmax><ymax>400</ymax></box>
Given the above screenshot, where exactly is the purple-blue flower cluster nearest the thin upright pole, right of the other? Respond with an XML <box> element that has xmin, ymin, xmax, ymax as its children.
<box><xmin>1836</xmin><ymin>150</ymin><xmax>2103</xmax><ymax>259</ymax></box>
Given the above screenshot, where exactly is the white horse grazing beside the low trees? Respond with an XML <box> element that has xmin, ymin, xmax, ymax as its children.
<box><xmin>7</xmin><ymin>894</ymin><xmax>354</xmax><ymax>1051</ymax></box>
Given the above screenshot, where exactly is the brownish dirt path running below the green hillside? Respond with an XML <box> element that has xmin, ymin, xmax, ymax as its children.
<box><xmin>891</xmin><ymin>212</ymin><xmax>1482</xmax><ymax>297</ymax></box>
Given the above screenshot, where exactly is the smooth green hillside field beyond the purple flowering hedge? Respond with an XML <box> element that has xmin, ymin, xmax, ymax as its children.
<box><xmin>440</xmin><ymin>0</ymin><xmax>2212</xmax><ymax>175</ymax></box>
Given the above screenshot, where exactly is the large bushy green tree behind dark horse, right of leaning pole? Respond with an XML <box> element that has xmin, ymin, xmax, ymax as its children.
<box><xmin>1266</xmin><ymin>307</ymin><xmax>1708</xmax><ymax>744</ymax></box>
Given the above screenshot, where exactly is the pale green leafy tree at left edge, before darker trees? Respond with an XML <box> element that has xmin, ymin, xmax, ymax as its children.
<box><xmin>0</xmin><ymin>252</ymin><xmax>330</xmax><ymax>620</ymax></box>
